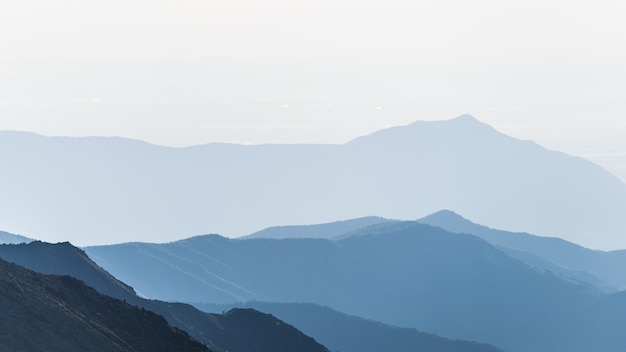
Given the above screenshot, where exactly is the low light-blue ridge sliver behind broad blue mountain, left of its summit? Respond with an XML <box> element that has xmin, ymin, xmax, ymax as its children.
<box><xmin>240</xmin><ymin>216</ymin><xmax>391</xmax><ymax>239</ymax></box>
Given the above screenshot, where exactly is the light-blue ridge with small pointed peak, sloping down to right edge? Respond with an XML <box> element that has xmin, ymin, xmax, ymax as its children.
<box><xmin>419</xmin><ymin>211</ymin><xmax>626</xmax><ymax>291</ymax></box>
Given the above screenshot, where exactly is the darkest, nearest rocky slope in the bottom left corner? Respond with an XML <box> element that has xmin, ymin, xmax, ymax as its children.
<box><xmin>0</xmin><ymin>259</ymin><xmax>209</xmax><ymax>352</ymax></box>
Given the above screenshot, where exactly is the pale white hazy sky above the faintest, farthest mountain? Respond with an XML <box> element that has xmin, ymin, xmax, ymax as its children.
<box><xmin>0</xmin><ymin>0</ymin><xmax>626</xmax><ymax>179</ymax></box>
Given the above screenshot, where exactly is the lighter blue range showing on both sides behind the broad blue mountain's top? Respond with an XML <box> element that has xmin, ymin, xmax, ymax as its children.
<box><xmin>235</xmin><ymin>210</ymin><xmax>626</xmax><ymax>292</ymax></box>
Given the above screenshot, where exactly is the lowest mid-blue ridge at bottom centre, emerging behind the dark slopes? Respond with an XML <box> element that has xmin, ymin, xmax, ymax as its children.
<box><xmin>198</xmin><ymin>302</ymin><xmax>501</xmax><ymax>352</ymax></box>
